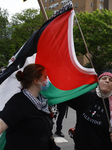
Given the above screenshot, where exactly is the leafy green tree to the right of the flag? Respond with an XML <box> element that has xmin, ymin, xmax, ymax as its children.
<box><xmin>74</xmin><ymin>9</ymin><xmax>112</xmax><ymax>74</ymax></box>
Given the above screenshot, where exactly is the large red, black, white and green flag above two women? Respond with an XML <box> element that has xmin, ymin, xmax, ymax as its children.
<box><xmin>0</xmin><ymin>2</ymin><xmax>98</xmax><ymax>110</ymax></box>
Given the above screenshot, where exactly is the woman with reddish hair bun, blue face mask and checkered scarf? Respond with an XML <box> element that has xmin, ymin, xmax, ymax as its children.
<box><xmin>0</xmin><ymin>64</ymin><xmax>57</xmax><ymax>150</ymax></box>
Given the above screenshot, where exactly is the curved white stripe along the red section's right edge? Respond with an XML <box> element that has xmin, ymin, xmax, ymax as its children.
<box><xmin>68</xmin><ymin>10</ymin><xmax>96</xmax><ymax>75</ymax></box>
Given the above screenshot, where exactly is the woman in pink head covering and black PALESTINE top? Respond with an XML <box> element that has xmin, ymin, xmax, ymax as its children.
<box><xmin>65</xmin><ymin>72</ymin><xmax>112</xmax><ymax>150</ymax></box>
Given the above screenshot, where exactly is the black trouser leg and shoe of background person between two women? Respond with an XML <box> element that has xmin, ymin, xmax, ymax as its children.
<box><xmin>55</xmin><ymin>103</ymin><xmax>67</xmax><ymax>137</ymax></box>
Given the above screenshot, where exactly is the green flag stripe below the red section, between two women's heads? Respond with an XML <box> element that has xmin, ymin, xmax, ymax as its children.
<box><xmin>41</xmin><ymin>83</ymin><xmax>97</xmax><ymax>105</ymax></box>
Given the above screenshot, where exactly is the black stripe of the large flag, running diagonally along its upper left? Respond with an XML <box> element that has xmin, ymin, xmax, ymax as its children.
<box><xmin>0</xmin><ymin>2</ymin><xmax>72</xmax><ymax>84</ymax></box>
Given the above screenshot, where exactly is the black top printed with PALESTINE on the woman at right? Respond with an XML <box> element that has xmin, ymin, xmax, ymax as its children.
<box><xmin>66</xmin><ymin>91</ymin><xmax>112</xmax><ymax>150</ymax></box>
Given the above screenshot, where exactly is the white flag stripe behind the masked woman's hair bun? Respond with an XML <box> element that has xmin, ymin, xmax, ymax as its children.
<box><xmin>0</xmin><ymin>53</ymin><xmax>36</xmax><ymax>111</ymax></box>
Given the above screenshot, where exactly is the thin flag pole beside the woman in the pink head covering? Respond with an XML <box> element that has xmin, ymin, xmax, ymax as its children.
<box><xmin>75</xmin><ymin>14</ymin><xmax>112</xmax><ymax>132</ymax></box>
